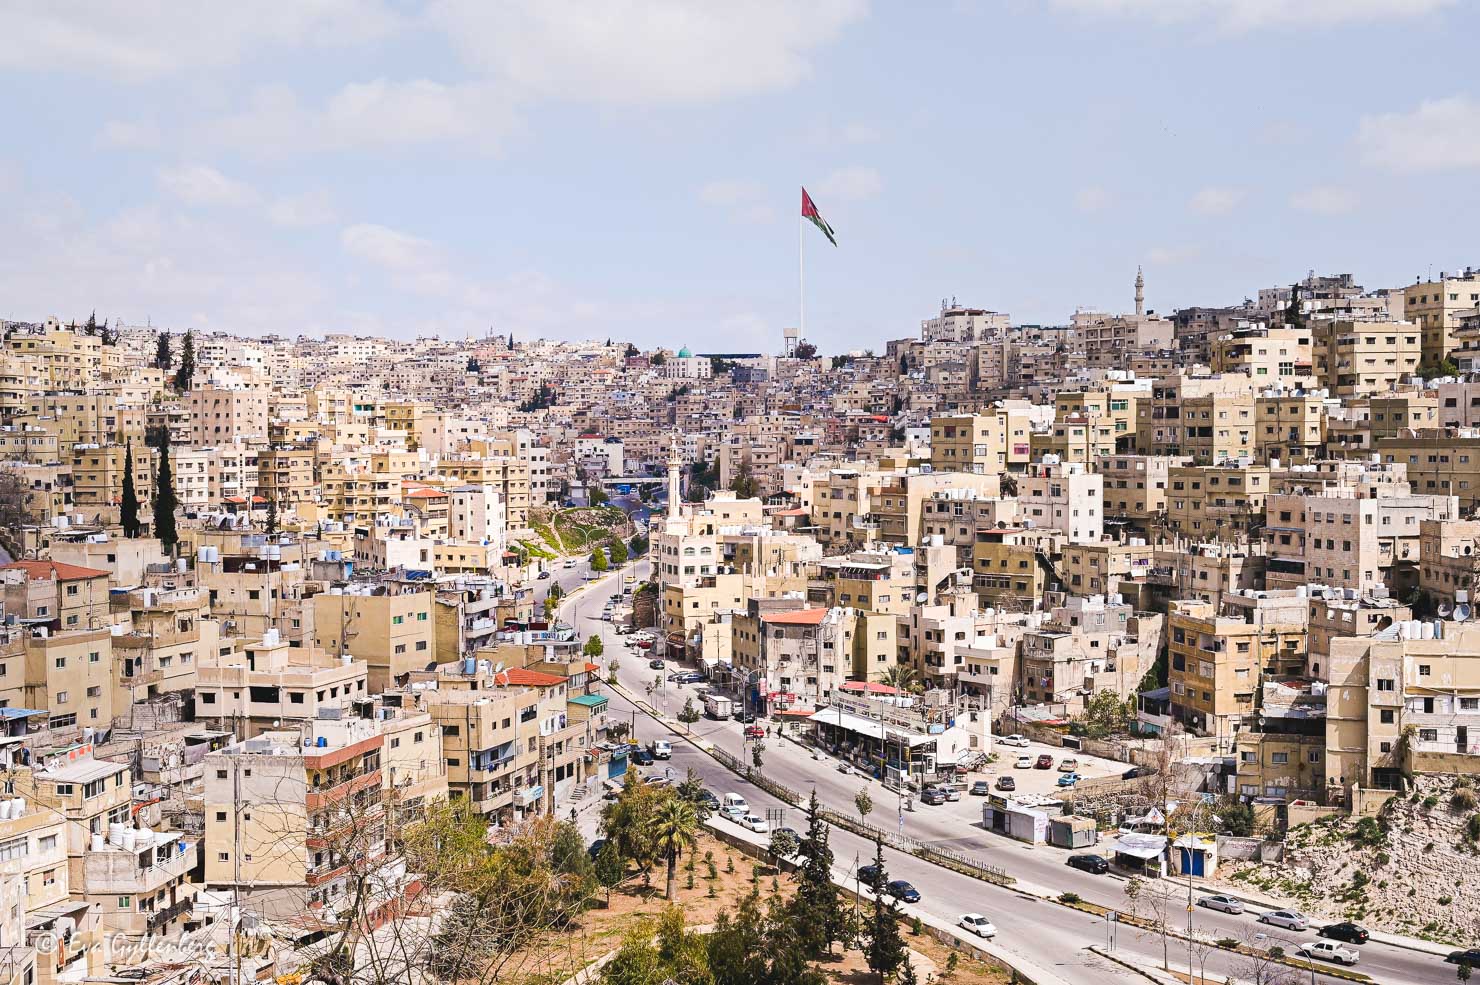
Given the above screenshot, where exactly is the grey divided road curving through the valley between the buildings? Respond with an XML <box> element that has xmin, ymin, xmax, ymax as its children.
<box><xmin>562</xmin><ymin>563</ymin><xmax>1453</xmax><ymax>985</ymax></box>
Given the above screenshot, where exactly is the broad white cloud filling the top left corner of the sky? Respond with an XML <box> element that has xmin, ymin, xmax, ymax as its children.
<box><xmin>0</xmin><ymin>0</ymin><xmax>401</xmax><ymax>78</ymax></box>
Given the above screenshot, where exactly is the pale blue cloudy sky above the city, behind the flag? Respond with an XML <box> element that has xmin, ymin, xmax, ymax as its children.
<box><xmin>0</xmin><ymin>0</ymin><xmax>1480</xmax><ymax>352</ymax></box>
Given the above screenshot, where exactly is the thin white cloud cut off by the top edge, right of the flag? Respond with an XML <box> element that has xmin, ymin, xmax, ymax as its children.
<box><xmin>1054</xmin><ymin>0</ymin><xmax>1458</xmax><ymax>34</ymax></box>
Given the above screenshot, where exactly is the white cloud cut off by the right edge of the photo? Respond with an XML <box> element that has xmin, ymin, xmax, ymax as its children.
<box><xmin>1357</xmin><ymin>96</ymin><xmax>1480</xmax><ymax>173</ymax></box>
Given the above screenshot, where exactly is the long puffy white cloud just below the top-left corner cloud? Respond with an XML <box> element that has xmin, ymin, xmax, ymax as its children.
<box><xmin>213</xmin><ymin>78</ymin><xmax>518</xmax><ymax>157</ymax></box>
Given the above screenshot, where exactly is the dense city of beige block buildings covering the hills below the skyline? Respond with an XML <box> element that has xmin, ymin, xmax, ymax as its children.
<box><xmin>0</xmin><ymin>268</ymin><xmax>1480</xmax><ymax>985</ymax></box>
